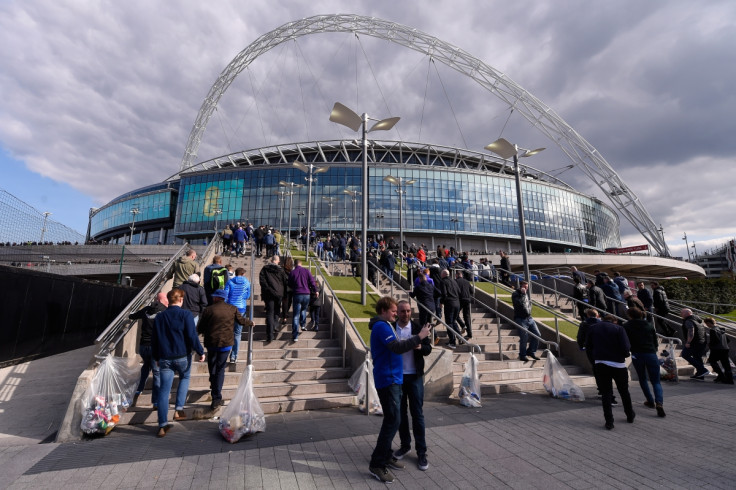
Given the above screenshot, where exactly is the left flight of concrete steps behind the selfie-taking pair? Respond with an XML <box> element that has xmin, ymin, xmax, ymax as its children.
<box><xmin>122</xmin><ymin>247</ymin><xmax>355</xmax><ymax>424</ymax></box>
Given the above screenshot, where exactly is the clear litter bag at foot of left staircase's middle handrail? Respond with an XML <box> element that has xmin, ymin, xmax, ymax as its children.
<box><xmin>220</xmin><ymin>366</ymin><xmax>266</xmax><ymax>443</ymax></box>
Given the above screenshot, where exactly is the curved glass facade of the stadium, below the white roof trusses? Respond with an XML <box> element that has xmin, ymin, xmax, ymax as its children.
<box><xmin>91</xmin><ymin>141</ymin><xmax>620</xmax><ymax>250</ymax></box>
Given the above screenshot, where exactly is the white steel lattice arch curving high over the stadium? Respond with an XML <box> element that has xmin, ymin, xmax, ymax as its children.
<box><xmin>181</xmin><ymin>14</ymin><xmax>669</xmax><ymax>256</ymax></box>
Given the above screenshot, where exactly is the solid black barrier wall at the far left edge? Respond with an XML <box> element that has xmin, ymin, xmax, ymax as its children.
<box><xmin>0</xmin><ymin>266</ymin><xmax>140</xmax><ymax>364</ymax></box>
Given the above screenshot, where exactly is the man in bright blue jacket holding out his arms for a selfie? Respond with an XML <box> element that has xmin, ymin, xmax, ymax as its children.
<box><xmin>368</xmin><ymin>296</ymin><xmax>429</xmax><ymax>483</ymax></box>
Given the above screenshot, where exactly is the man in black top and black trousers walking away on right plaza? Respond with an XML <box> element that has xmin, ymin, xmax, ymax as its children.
<box><xmin>585</xmin><ymin>321</ymin><xmax>636</xmax><ymax>430</ymax></box>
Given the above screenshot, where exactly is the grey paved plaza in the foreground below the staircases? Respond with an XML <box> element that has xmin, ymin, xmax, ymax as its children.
<box><xmin>0</xmin><ymin>346</ymin><xmax>736</xmax><ymax>490</ymax></box>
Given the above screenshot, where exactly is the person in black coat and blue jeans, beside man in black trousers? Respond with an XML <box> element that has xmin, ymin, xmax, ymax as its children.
<box><xmin>624</xmin><ymin>308</ymin><xmax>665</xmax><ymax>417</ymax></box>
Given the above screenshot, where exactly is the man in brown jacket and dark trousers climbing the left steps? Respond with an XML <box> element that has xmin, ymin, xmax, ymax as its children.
<box><xmin>197</xmin><ymin>289</ymin><xmax>248</xmax><ymax>410</ymax></box>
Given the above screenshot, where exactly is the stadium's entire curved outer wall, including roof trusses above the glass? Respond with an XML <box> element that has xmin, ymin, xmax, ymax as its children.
<box><xmin>89</xmin><ymin>141</ymin><xmax>620</xmax><ymax>251</ymax></box>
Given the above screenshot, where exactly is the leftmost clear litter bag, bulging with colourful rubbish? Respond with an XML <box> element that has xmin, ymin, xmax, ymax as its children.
<box><xmin>81</xmin><ymin>355</ymin><xmax>140</xmax><ymax>435</ymax></box>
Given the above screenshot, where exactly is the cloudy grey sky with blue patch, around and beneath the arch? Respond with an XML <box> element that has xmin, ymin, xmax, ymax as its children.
<box><xmin>0</xmin><ymin>0</ymin><xmax>736</xmax><ymax>255</ymax></box>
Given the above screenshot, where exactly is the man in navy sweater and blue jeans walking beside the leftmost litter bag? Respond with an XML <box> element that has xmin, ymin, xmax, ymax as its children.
<box><xmin>151</xmin><ymin>289</ymin><xmax>205</xmax><ymax>437</ymax></box>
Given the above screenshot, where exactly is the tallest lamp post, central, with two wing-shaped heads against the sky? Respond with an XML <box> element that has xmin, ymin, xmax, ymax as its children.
<box><xmin>330</xmin><ymin>102</ymin><xmax>400</xmax><ymax>306</ymax></box>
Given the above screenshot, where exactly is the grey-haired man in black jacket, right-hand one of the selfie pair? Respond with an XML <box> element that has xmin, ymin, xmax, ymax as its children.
<box><xmin>394</xmin><ymin>300</ymin><xmax>432</xmax><ymax>471</ymax></box>
